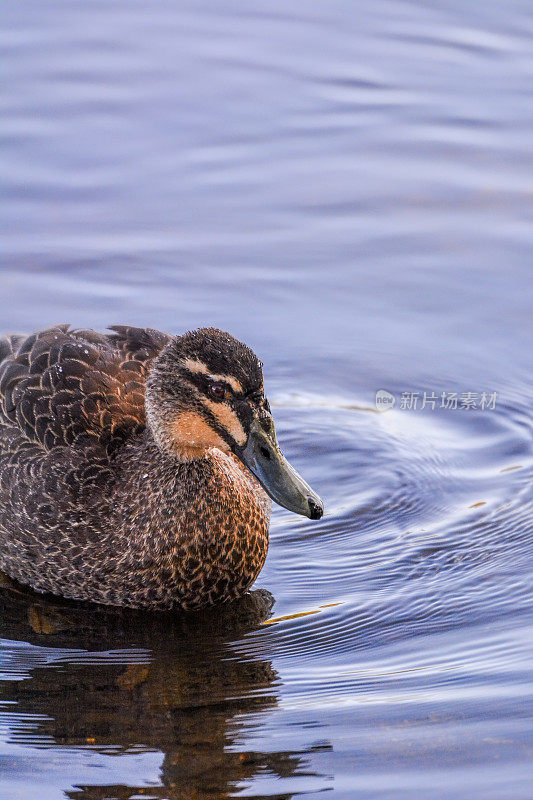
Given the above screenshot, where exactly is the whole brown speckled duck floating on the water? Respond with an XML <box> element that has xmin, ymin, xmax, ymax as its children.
<box><xmin>0</xmin><ymin>325</ymin><xmax>324</xmax><ymax>610</ymax></box>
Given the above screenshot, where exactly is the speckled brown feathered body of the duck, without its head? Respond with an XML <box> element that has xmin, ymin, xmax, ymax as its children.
<box><xmin>0</xmin><ymin>325</ymin><xmax>270</xmax><ymax>608</ymax></box>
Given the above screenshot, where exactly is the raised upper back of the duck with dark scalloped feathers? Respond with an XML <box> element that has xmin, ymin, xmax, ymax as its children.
<box><xmin>0</xmin><ymin>325</ymin><xmax>170</xmax><ymax>452</ymax></box>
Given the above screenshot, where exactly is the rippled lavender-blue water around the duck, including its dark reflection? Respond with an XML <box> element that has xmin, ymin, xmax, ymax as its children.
<box><xmin>0</xmin><ymin>0</ymin><xmax>533</xmax><ymax>800</ymax></box>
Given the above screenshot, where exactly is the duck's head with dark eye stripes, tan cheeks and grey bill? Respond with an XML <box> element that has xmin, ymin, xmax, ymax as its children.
<box><xmin>146</xmin><ymin>328</ymin><xmax>324</xmax><ymax>519</ymax></box>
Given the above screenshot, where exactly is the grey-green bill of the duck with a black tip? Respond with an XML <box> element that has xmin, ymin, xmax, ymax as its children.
<box><xmin>239</xmin><ymin>421</ymin><xmax>324</xmax><ymax>519</ymax></box>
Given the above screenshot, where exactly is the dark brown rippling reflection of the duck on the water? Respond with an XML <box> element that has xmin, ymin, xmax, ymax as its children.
<box><xmin>0</xmin><ymin>586</ymin><xmax>310</xmax><ymax>800</ymax></box>
